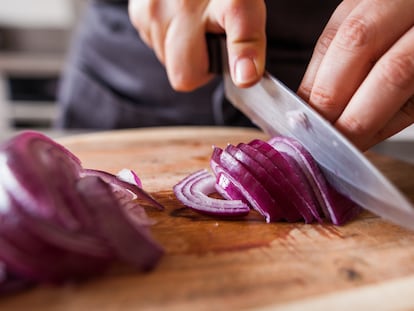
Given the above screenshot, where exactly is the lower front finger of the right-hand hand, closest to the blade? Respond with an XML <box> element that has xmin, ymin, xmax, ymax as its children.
<box><xmin>335</xmin><ymin>27</ymin><xmax>414</xmax><ymax>149</ymax></box>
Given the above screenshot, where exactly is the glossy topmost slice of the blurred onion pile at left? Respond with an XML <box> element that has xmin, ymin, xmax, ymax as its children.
<box><xmin>0</xmin><ymin>137</ymin><xmax>88</xmax><ymax>229</ymax></box>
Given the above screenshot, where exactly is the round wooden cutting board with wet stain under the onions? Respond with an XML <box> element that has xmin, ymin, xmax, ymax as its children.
<box><xmin>0</xmin><ymin>127</ymin><xmax>414</xmax><ymax>311</ymax></box>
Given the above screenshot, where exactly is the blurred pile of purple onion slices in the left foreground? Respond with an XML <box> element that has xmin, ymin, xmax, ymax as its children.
<box><xmin>0</xmin><ymin>131</ymin><xmax>163</xmax><ymax>293</ymax></box>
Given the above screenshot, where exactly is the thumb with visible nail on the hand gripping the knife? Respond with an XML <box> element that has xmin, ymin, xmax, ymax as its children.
<box><xmin>210</xmin><ymin>0</ymin><xmax>266</xmax><ymax>87</ymax></box>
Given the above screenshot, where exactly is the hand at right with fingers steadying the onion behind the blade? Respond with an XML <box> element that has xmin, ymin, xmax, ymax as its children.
<box><xmin>298</xmin><ymin>0</ymin><xmax>414</xmax><ymax>150</ymax></box>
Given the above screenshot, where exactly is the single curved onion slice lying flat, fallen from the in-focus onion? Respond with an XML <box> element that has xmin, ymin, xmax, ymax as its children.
<box><xmin>174</xmin><ymin>170</ymin><xmax>250</xmax><ymax>217</ymax></box>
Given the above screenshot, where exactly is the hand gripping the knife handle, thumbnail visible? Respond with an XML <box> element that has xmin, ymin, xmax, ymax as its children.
<box><xmin>129</xmin><ymin>0</ymin><xmax>266</xmax><ymax>91</ymax></box>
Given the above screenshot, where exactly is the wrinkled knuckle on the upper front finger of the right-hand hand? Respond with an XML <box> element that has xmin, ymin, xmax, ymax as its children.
<box><xmin>337</xmin><ymin>17</ymin><xmax>374</xmax><ymax>49</ymax></box>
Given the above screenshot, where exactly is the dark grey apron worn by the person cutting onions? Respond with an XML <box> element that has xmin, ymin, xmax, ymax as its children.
<box><xmin>57</xmin><ymin>0</ymin><xmax>340</xmax><ymax>129</ymax></box>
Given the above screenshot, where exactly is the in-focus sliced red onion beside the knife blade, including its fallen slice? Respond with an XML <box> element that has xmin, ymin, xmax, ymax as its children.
<box><xmin>174</xmin><ymin>137</ymin><xmax>361</xmax><ymax>225</ymax></box>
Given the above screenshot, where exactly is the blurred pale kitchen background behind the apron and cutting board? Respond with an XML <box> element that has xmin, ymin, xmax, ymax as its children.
<box><xmin>0</xmin><ymin>0</ymin><xmax>414</xmax><ymax>163</ymax></box>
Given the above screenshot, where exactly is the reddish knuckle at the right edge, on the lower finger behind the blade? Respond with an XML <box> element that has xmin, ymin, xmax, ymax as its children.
<box><xmin>378</xmin><ymin>53</ymin><xmax>414</xmax><ymax>90</ymax></box>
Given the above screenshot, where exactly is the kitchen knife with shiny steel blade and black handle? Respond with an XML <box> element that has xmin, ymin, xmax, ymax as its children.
<box><xmin>207</xmin><ymin>34</ymin><xmax>414</xmax><ymax>230</ymax></box>
